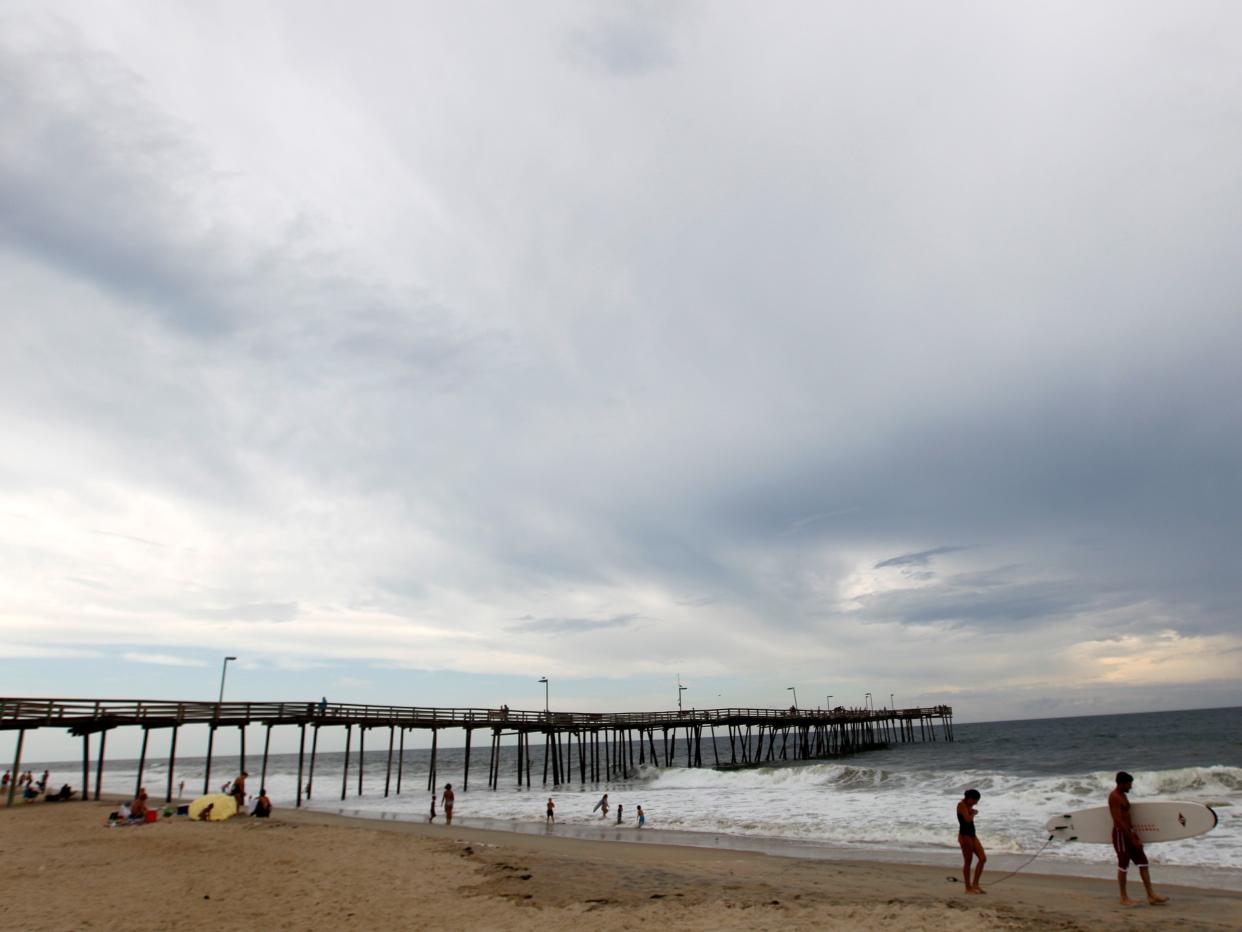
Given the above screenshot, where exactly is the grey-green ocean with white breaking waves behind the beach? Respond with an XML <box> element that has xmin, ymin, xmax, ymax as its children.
<box><xmin>21</xmin><ymin>708</ymin><xmax>1242</xmax><ymax>890</ymax></box>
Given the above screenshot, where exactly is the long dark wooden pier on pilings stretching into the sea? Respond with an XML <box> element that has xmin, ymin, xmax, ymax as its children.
<box><xmin>0</xmin><ymin>698</ymin><xmax>953</xmax><ymax>806</ymax></box>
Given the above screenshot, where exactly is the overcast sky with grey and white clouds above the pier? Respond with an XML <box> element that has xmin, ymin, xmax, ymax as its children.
<box><xmin>0</xmin><ymin>0</ymin><xmax>1242</xmax><ymax>745</ymax></box>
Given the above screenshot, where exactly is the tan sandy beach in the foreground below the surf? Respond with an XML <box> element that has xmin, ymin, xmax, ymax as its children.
<box><xmin>0</xmin><ymin>803</ymin><xmax>1242</xmax><ymax>932</ymax></box>
